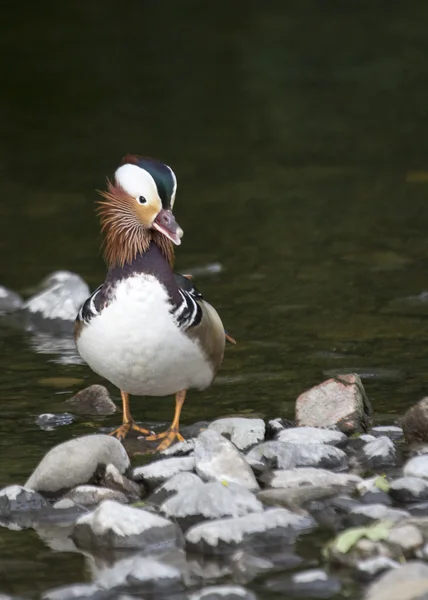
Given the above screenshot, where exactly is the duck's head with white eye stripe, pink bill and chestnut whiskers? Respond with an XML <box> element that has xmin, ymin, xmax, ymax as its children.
<box><xmin>98</xmin><ymin>154</ymin><xmax>183</xmax><ymax>266</ymax></box>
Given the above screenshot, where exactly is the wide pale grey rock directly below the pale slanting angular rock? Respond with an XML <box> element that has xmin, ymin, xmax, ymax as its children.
<box><xmin>161</xmin><ymin>481</ymin><xmax>263</xmax><ymax>529</ymax></box>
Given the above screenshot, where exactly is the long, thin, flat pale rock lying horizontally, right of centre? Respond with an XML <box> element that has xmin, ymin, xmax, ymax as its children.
<box><xmin>265</xmin><ymin>467</ymin><xmax>361</xmax><ymax>491</ymax></box>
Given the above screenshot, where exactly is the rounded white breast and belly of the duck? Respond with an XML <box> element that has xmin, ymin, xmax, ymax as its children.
<box><xmin>77</xmin><ymin>275</ymin><xmax>213</xmax><ymax>396</ymax></box>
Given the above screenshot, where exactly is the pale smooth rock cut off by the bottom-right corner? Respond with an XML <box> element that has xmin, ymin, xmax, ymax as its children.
<box><xmin>364</xmin><ymin>561</ymin><xmax>428</xmax><ymax>600</ymax></box>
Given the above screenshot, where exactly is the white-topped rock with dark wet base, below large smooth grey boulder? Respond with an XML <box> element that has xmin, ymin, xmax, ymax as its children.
<box><xmin>72</xmin><ymin>500</ymin><xmax>183</xmax><ymax>552</ymax></box>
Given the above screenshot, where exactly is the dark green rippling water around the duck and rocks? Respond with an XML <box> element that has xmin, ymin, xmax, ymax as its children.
<box><xmin>0</xmin><ymin>0</ymin><xmax>428</xmax><ymax>593</ymax></box>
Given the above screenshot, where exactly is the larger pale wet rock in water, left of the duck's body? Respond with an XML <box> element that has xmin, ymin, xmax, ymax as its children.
<box><xmin>24</xmin><ymin>271</ymin><xmax>90</xmax><ymax>321</ymax></box>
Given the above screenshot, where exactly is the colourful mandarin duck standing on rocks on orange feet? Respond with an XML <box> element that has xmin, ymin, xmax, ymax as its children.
<box><xmin>74</xmin><ymin>154</ymin><xmax>235</xmax><ymax>451</ymax></box>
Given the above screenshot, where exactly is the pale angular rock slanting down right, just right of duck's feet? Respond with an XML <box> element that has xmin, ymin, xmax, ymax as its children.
<box><xmin>195</xmin><ymin>430</ymin><xmax>259</xmax><ymax>490</ymax></box>
